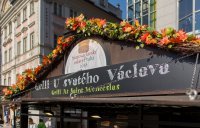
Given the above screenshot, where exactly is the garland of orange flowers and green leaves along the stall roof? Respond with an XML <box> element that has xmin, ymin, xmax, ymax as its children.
<box><xmin>2</xmin><ymin>14</ymin><xmax>200</xmax><ymax>98</ymax></box>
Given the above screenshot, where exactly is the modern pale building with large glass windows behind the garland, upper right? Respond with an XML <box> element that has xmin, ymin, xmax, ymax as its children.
<box><xmin>127</xmin><ymin>0</ymin><xmax>200</xmax><ymax>35</ymax></box>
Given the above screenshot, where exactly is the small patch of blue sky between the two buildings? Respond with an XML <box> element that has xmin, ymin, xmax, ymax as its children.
<box><xmin>108</xmin><ymin>0</ymin><xmax>126</xmax><ymax>19</ymax></box>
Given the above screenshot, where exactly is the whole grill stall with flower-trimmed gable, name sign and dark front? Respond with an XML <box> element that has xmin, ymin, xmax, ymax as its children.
<box><xmin>3</xmin><ymin>16</ymin><xmax>200</xmax><ymax>128</ymax></box>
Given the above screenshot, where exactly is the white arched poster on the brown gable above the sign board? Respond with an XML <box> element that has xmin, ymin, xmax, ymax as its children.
<box><xmin>65</xmin><ymin>39</ymin><xmax>107</xmax><ymax>74</ymax></box>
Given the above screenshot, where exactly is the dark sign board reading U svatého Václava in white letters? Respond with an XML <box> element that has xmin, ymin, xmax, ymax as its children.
<box><xmin>31</xmin><ymin>56</ymin><xmax>199</xmax><ymax>98</ymax></box>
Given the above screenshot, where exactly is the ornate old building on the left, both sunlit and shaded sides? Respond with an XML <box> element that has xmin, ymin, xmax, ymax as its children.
<box><xmin>0</xmin><ymin>0</ymin><xmax>121</xmax><ymax>85</ymax></box>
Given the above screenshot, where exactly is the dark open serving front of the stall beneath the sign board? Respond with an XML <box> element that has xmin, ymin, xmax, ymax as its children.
<box><xmin>18</xmin><ymin>98</ymin><xmax>200</xmax><ymax>128</ymax></box>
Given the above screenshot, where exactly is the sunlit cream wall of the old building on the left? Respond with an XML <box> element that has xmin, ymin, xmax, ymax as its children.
<box><xmin>0</xmin><ymin>0</ymin><xmax>40</xmax><ymax>85</ymax></box>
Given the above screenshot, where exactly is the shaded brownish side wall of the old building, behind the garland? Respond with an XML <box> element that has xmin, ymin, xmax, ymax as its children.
<box><xmin>40</xmin><ymin>0</ymin><xmax>120</xmax><ymax>55</ymax></box>
